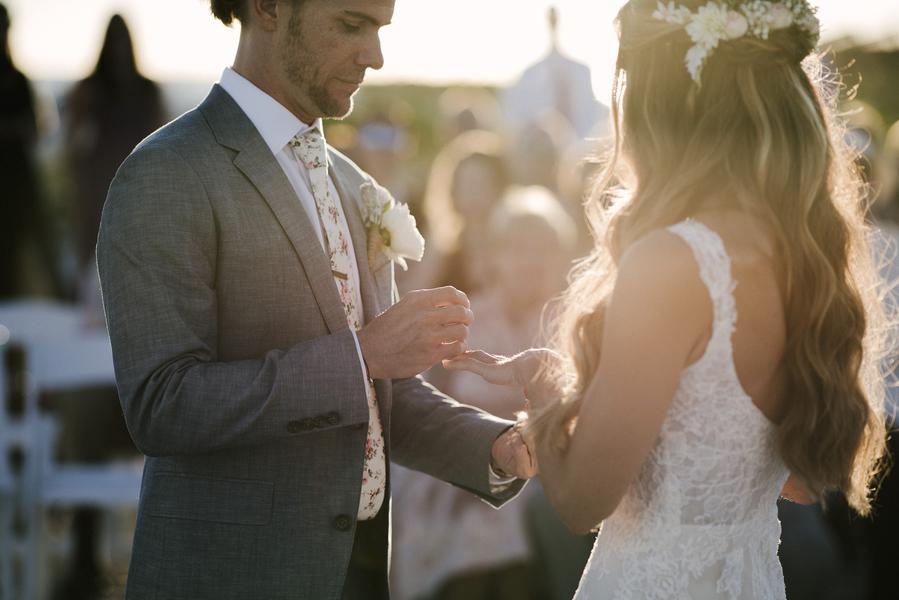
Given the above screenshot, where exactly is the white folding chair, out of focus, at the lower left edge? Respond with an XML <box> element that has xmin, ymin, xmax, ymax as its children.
<box><xmin>0</xmin><ymin>302</ymin><xmax>142</xmax><ymax>600</ymax></box>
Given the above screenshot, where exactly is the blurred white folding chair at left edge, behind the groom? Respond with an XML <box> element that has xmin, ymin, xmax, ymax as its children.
<box><xmin>0</xmin><ymin>302</ymin><xmax>142</xmax><ymax>600</ymax></box>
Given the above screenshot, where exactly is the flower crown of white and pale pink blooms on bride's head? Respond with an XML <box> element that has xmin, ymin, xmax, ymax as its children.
<box><xmin>652</xmin><ymin>0</ymin><xmax>821</xmax><ymax>85</ymax></box>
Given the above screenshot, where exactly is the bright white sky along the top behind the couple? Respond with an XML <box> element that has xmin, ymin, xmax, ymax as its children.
<box><xmin>0</xmin><ymin>0</ymin><xmax>899</xmax><ymax>99</ymax></box>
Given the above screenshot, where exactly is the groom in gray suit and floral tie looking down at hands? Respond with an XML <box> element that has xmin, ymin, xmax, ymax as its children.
<box><xmin>97</xmin><ymin>0</ymin><xmax>532</xmax><ymax>600</ymax></box>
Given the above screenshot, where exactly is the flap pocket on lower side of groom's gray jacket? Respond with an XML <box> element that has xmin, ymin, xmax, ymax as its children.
<box><xmin>143</xmin><ymin>473</ymin><xmax>275</xmax><ymax>525</ymax></box>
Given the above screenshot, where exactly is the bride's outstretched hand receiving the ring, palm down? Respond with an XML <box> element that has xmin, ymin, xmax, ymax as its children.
<box><xmin>443</xmin><ymin>348</ymin><xmax>562</xmax><ymax>408</ymax></box>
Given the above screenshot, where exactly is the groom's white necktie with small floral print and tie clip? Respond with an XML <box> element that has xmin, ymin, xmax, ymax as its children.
<box><xmin>290</xmin><ymin>127</ymin><xmax>387</xmax><ymax>520</ymax></box>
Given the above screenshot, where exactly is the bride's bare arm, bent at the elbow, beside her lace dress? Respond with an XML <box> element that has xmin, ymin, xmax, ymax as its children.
<box><xmin>537</xmin><ymin>232</ymin><xmax>712</xmax><ymax>532</ymax></box>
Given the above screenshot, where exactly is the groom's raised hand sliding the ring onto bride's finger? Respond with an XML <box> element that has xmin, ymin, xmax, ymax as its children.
<box><xmin>358</xmin><ymin>287</ymin><xmax>474</xmax><ymax>379</ymax></box>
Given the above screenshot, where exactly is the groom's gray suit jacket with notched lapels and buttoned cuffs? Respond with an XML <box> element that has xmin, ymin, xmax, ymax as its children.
<box><xmin>97</xmin><ymin>87</ymin><xmax>520</xmax><ymax>600</ymax></box>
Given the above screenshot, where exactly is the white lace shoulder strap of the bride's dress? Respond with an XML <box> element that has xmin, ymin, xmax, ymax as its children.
<box><xmin>668</xmin><ymin>219</ymin><xmax>737</xmax><ymax>340</ymax></box>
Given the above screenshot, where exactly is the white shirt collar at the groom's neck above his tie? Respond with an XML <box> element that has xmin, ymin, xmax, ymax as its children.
<box><xmin>219</xmin><ymin>67</ymin><xmax>324</xmax><ymax>154</ymax></box>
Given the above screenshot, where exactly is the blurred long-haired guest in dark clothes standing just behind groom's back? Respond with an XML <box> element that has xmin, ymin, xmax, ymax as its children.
<box><xmin>56</xmin><ymin>15</ymin><xmax>164</xmax><ymax>600</ymax></box>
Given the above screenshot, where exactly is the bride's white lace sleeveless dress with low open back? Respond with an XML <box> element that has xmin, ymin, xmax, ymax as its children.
<box><xmin>575</xmin><ymin>220</ymin><xmax>789</xmax><ymax>600</ymax></box>
